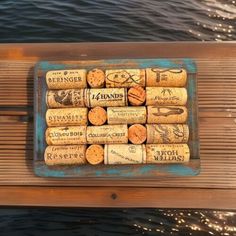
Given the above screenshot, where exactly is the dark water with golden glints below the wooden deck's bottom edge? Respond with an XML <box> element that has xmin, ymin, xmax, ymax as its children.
<box><xmin>0</xmin><ymin>209</ymin><xmax>236</xmax><ymax>236</ymax></box>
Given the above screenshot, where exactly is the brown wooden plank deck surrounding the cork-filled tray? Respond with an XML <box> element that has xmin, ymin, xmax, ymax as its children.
<box><xmin>0</xmin><ymin>42</ymin><xmax>236</xmax><ymax>209</ymax></box>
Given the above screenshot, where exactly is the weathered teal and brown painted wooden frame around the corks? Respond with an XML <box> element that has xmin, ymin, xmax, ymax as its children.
<box><xmin>34</xmin><ymin>58</ymin><xmax>200</xmax><ymax>179</ymax></box>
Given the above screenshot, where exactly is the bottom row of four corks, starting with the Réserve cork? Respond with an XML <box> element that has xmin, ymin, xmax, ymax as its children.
<box><xmin>44</xmin><ymin>144</ymin><xmax>190</xmax><ymax>165</ymax></box>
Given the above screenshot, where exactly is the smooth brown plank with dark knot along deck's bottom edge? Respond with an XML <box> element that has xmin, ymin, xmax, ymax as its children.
<box><xmin>0</xmin><ymin>187</ymin><xmax>236</xmax><ymax>210</ymax></box>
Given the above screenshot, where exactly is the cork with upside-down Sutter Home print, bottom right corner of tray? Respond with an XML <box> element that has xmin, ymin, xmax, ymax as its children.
<box><xmin>146</xmin><ymin>144</ymin><xmax>190</xmax><ymax>163</ymax></box>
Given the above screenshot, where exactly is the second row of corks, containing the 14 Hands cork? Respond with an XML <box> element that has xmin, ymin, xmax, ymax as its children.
<box><xmin>46</xmin><ymin>86</ymin><xmax>188</xmax><ymax>108</ymax></box>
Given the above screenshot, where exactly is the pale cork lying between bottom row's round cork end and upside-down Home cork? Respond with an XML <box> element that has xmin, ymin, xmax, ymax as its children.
<box><xmin>104</xmin><ymin>144</ymin><xmax>146</xmax><ymax>165</ymax></box>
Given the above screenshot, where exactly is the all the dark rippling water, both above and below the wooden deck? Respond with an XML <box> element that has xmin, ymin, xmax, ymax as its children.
<box><xmin>0</xmin><ymin>0</ymin><xmax>236</xmax><ymax>236</ymax></box>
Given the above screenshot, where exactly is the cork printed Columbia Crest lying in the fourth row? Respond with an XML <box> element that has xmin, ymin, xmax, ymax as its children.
<box><xmin>87</xmin><ymin>125</ymin><xmax>128</xmax><ymax>144</ymax></box>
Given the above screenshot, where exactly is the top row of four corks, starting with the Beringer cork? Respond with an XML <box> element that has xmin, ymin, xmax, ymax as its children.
<box><xmin>46</xmin><ymin>68</ymin><xmax>187</xmax><ymax>89</ymax></box>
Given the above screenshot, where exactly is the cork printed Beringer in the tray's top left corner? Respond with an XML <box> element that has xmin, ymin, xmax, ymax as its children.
<box><xmin>46</xmin><ymin>69</ymin><xmax>87</xmax><ymax>89</ymax></box>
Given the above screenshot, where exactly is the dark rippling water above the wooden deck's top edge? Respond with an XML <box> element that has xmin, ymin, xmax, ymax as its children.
<box><xmin>0</xmin><ymin>0</ymin><xmax>236</xmax><ymax>42</ymax></box>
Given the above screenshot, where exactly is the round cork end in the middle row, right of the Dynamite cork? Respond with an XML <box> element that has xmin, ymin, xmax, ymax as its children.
<box><xmin>88</xmin><ymin>107</ymin><xmax>107</xmax><ymax>125</ymax></box>
